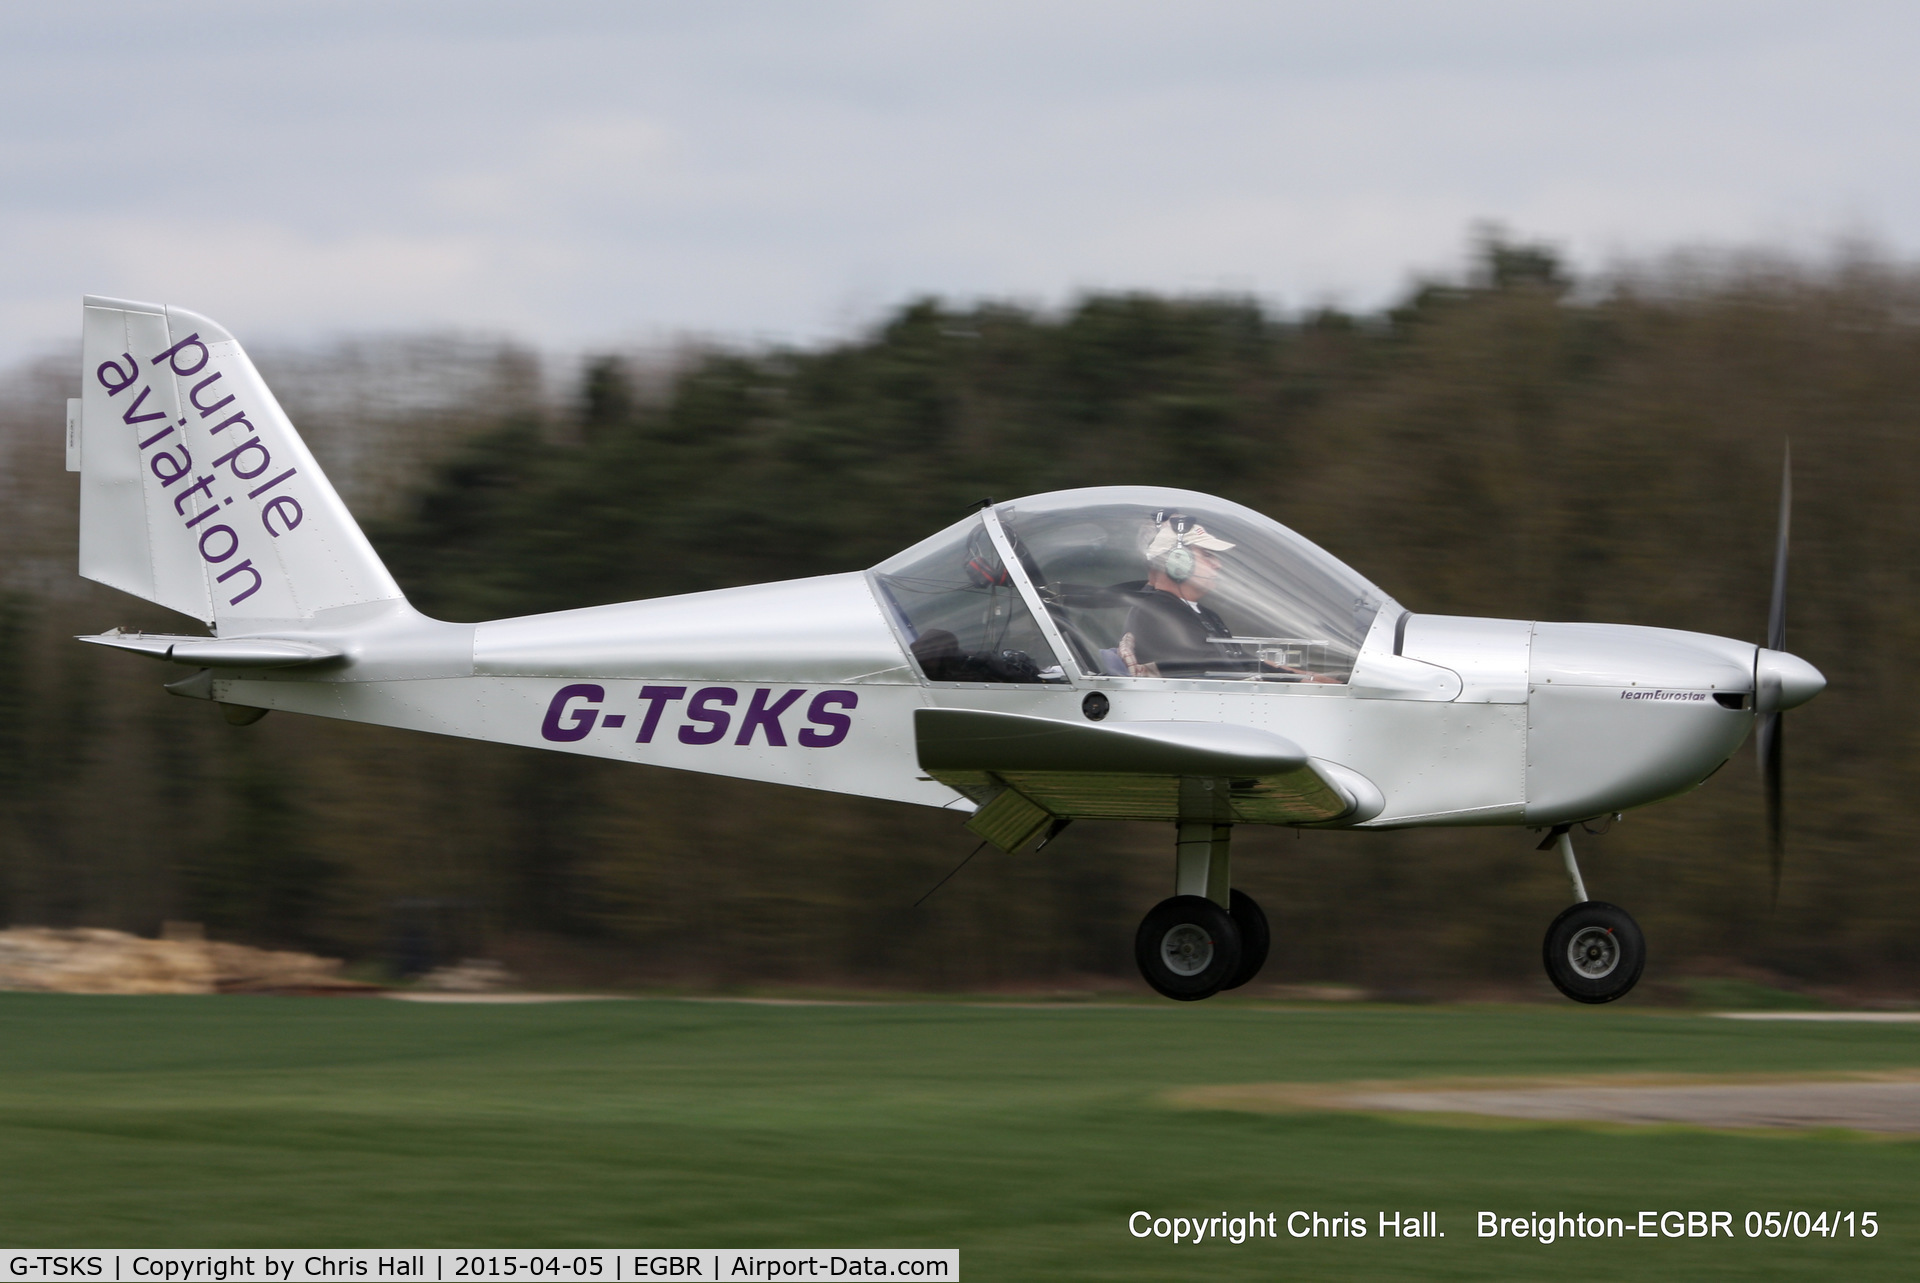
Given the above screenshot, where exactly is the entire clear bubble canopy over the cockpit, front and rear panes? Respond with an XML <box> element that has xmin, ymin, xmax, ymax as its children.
<box><xmin>876</xmin><ymin>486</ymin><xmax>1386</xmax><ymax>682</ymax></box>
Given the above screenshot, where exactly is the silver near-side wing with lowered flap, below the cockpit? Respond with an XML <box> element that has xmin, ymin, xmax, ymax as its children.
<box><xmin>914</xmin><ymin>709</ymin><xmax>1357</xmax><ymax>851</ymax></box>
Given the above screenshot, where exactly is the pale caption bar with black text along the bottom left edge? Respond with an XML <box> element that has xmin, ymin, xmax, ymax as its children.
<box><xmin>0</xmin><ymin>1247</ymin><xmax>960</xmax><ymax>1283</ymax></box>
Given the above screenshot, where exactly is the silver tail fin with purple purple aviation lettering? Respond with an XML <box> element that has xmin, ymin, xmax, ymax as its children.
<box><xmin>69</xmin><ymin>296</ymin><xmax>401</xmax><ymax>634</ymax></box>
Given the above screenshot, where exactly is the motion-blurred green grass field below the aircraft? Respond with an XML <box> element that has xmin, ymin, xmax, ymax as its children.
<box><xmin>0</xmin><ymin>995</ymin><xmax>1920</xmax><ymax>1279</ymax></box>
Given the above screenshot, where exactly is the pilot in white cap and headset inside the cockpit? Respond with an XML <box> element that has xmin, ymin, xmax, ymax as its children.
<box><xmin>1119</xmin><ymin>513</ymin><xmax>1261</xmax><ymax>678</ymax></box>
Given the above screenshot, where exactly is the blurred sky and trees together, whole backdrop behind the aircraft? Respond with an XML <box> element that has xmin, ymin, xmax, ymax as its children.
<box><xmin>0</xmin><ymin>2</ymin><xmax>1920</xmax><ymax>1001</ymax></box>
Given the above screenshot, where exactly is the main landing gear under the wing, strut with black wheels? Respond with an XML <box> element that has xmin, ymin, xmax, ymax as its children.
<box><xmin>1133</xmin><ymin>820</ymin><xmax>1271</xmax><ymax>1003</ymax></box>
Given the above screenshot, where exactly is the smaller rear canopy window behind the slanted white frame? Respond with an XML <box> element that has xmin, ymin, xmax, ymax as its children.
<box><xmin>874</xmin><ymin>517</ymin><xmax>1068</xmax><ymax>686</ymax></box>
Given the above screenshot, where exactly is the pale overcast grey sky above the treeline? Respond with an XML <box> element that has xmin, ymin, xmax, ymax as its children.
<box><xmin>0</xmin><ymin>0</ymin><xmax>1920</xmax><ymax>355</ymax></box>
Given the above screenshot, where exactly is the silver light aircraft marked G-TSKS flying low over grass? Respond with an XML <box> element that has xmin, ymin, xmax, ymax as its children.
<box><xmin>67</xmin><ymin>296</ymin><xmax>1826</xmax><ymax>1003</ymax></box>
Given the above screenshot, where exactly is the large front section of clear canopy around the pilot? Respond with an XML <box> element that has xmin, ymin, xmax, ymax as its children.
<box><xmin>996</xmin><ymin>486</ymin><xmax>1386</xmax><ymax>682</ymax></box>
